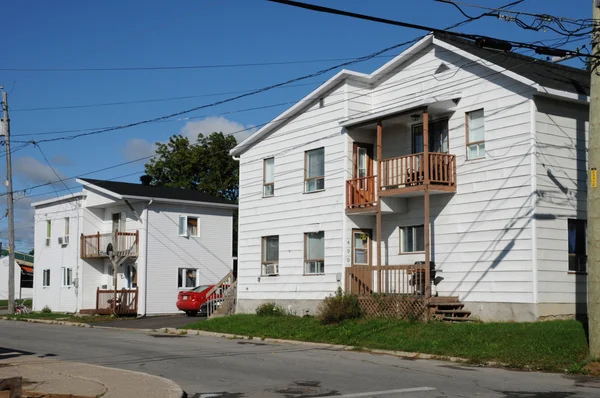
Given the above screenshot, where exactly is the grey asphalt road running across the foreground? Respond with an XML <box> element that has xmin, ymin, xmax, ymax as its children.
<box><xmin>0</xmin><ymin>321</ymin><xmax>600</xmax><ymax>398</ymax></box>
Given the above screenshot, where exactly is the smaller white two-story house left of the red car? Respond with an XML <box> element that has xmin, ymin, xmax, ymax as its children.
<box><xmin>32</xmin><ymin>176</ymin><xmax>237</xmax><ymax>315</ymax></box>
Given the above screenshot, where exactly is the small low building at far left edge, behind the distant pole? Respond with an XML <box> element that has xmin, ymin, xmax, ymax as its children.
<box><xmin>0</xmin><ymin>250</ymin><xmax>33</xmax><ymax>300</ymax></box>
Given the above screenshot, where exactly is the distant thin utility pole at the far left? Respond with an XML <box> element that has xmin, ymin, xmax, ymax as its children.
<box><xmin>2</xmin><ymin>91</ymin><xmax>15</xmax><ymax>314</ymax></box>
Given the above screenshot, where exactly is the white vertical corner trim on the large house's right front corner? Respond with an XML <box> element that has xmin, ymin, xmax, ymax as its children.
<box><xmin>529</xmin><ymin>98</ymin><xmax>539</xmax><ymax>320</ymax></box>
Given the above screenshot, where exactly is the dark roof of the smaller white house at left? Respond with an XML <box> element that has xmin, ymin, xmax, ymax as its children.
<box><xmin>81</xmin><ymin>178</ymin><xmax>235</xmax><ymax>205</ymax></box>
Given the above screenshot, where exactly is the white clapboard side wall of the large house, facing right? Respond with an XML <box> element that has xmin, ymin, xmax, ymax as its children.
<box><xmin>535</xmin><ymin>97</ymin><xmax>589</xmax><ymax>303</ymax></box>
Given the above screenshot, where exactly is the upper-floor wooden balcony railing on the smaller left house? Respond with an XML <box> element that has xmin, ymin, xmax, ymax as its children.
<box><xmin>81</xmin><ymin>231</ymin><xmax>140</xmax><ymax>258</ymax></box>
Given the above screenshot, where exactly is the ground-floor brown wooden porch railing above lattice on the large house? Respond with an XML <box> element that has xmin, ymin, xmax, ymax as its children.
<box><xmin>346</xmin><ymin>264</ymin><xmax>427</xmax><ymax>296</ymax></box>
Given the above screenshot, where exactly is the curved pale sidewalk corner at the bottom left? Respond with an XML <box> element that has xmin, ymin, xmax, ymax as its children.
<box><xmin>0</xmin><ymin>357</ymin><xmax>183</xmax><ymax>398</ymax></box>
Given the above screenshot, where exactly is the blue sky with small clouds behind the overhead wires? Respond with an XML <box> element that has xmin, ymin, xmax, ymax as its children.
<box><xmin>0</xmin><ymin>0</ymin><xmax>591</xmax><ymax>250</ymax></box>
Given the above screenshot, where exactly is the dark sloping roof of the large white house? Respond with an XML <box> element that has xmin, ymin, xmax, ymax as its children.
<box><xmin>434</xmin><ymin>33</ymin><xmax>590</xmax><ymax>96</ymax></box>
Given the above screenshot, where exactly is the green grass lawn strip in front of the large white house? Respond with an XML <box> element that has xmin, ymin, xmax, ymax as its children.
<box><xmin>185</xmin><ymin>314</ymin><xmax>588</xmax><ymax>372</ymax></box>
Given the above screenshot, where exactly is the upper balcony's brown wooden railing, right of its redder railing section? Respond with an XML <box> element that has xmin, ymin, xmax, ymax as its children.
<box><xmin>381</xmin><ymin>152</ymin><xmax>456</xmax><ymax>189</ymax></box>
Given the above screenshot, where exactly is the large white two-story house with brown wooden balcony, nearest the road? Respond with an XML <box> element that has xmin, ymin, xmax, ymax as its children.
<box><xmin>232</xmin><ymin>34</ymin><xmax>589</xmax><ymax>321</ymax></box>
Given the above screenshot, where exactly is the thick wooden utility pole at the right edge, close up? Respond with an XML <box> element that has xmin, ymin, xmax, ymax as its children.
<box><xmin>587</xmin><ymin>0</ymin><xmax>600</xmax><ymax>358</ymax></box>
